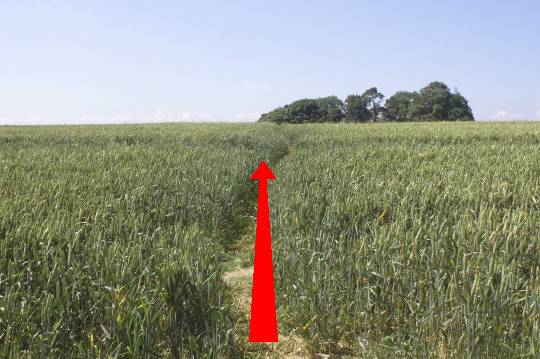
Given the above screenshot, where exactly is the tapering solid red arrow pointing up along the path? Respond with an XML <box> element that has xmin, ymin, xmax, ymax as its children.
<box><xmin>249</xmin><ymin>161</ymin><xmax>278</xmax><ymax>342</ymax></box>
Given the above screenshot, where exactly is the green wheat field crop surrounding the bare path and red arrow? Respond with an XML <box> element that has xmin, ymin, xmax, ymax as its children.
<box><xmin>0</xmin><ymin>123</ymin><xmax>540</xmax><ymax>357</ymax></box>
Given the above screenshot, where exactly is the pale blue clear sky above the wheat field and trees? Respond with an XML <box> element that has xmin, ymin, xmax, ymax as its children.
<box><xmin>0</xmin><ymin>0</ymin><xmax>540</xmax><ymax>124</ymax></box>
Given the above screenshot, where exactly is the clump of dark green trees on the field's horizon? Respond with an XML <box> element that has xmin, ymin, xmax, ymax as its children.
<box><xmin>259</xmin><ymin>82</ymin><xmax>474</xmax><ymax>123</ymax></box>
